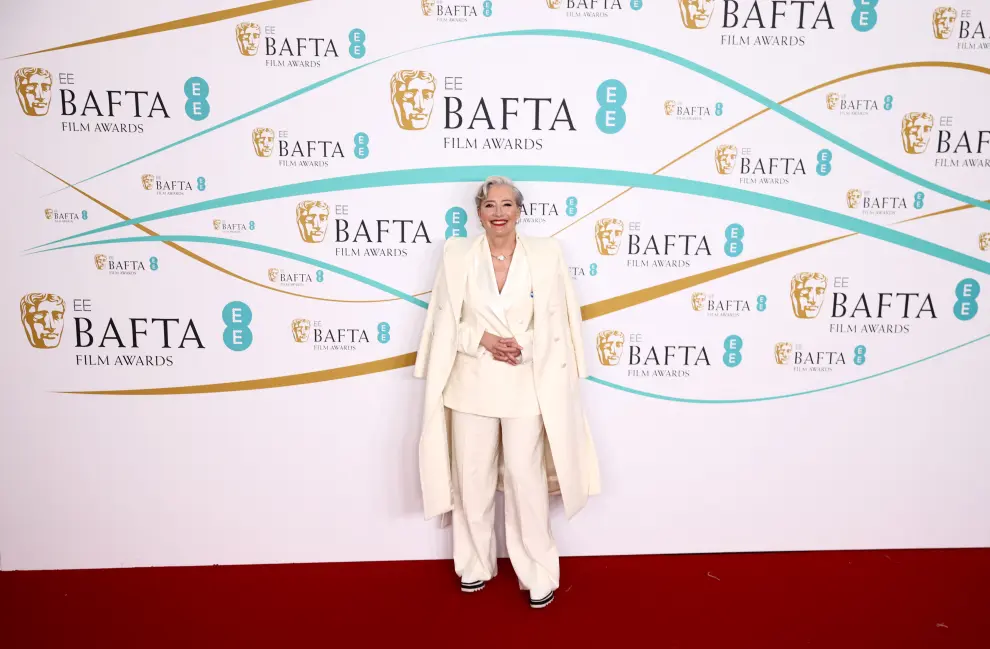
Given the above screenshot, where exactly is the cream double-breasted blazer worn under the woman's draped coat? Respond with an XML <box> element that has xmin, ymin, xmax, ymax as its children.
<box><xmin>443</xmin><ymin>236</ymin><xmax>540</xmax><ymax>417</ymax></box>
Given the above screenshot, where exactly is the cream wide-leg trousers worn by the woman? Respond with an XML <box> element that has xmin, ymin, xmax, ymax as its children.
<box><xmin>451</xmin><ymin>410</ymin><xmax>560</xmax><ymax>595</ymax></box>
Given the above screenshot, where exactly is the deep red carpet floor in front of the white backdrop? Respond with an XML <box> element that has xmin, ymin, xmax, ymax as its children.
<box><xmin>0</xmin><ymin>550</ymin><xmax>990</xmax><ymax>649</ymax></box>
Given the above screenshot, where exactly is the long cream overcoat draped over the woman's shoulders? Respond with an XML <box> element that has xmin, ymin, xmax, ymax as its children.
<box><xmin>413</xmin><ymin>234</ymin><xmax>601</xmax><ymax>519</ymax></box>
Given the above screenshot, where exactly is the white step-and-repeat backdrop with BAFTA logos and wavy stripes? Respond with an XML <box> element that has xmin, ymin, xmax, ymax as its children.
<box><xmin>0</xmin><ymin>0</ymin><xmax>990</xmax><ymax>569</ymax></box>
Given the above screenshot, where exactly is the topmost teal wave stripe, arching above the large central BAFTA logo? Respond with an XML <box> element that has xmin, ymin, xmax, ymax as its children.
<box><xmin>42</xmin><ymin>29</ymin><xmax>990</xmax><ymax>218</ymax></box>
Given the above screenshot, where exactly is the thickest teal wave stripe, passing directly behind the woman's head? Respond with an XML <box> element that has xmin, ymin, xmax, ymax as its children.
<box><xmin>30</xmin><ymin>165</ymin><xmax>990</xmax><ymax>274</ymax></box>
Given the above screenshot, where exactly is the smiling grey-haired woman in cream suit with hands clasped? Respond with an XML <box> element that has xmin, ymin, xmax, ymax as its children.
<box><xmin>414</xmin><ymin>176</ymin><xmax>600</xmax><ymax>608</ymax></box>
